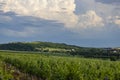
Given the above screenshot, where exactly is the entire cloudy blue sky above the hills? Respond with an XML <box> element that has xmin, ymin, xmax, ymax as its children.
<box><xmin>0</xmin><ymin>0</ymin><xmax>120</xmax><ymax>47</ymax></box>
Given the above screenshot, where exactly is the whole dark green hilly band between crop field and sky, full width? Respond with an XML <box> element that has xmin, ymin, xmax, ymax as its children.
<box><xmin>0</xmin><ymin>41</ymin><xmax>120</xmax><ymax>60</ymax></box>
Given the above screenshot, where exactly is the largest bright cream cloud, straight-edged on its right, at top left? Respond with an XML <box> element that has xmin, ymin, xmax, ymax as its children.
<box><xmin>0</xmin><ymin>0</ymin><xmax>77</xmax><ymax>25</ymax></box>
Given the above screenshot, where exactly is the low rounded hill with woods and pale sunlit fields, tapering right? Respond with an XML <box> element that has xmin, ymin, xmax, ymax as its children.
<box><xmin>0</xmin><ymin>41</ymin><xmax>81</xmax><ymax>52</ymax></box>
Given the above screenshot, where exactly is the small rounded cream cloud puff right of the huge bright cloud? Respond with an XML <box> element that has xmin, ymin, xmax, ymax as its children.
<box><xmin>78</xmin><ymin>10</ymin><xmax>104</xmax><ymax>27</ymax></box>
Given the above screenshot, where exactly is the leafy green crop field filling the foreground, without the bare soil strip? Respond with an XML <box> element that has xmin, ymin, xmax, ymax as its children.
<box><xmin>0</xmin><ymin>51</ymin><xmax>120</xmax><ymax>80</ymax></box>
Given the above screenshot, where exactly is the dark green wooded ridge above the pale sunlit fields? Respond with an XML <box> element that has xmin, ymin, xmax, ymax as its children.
<box><xmin>0</xmin><ymin>41</ymin><xmax>80</xmax><ymax>51</ymax></box>
